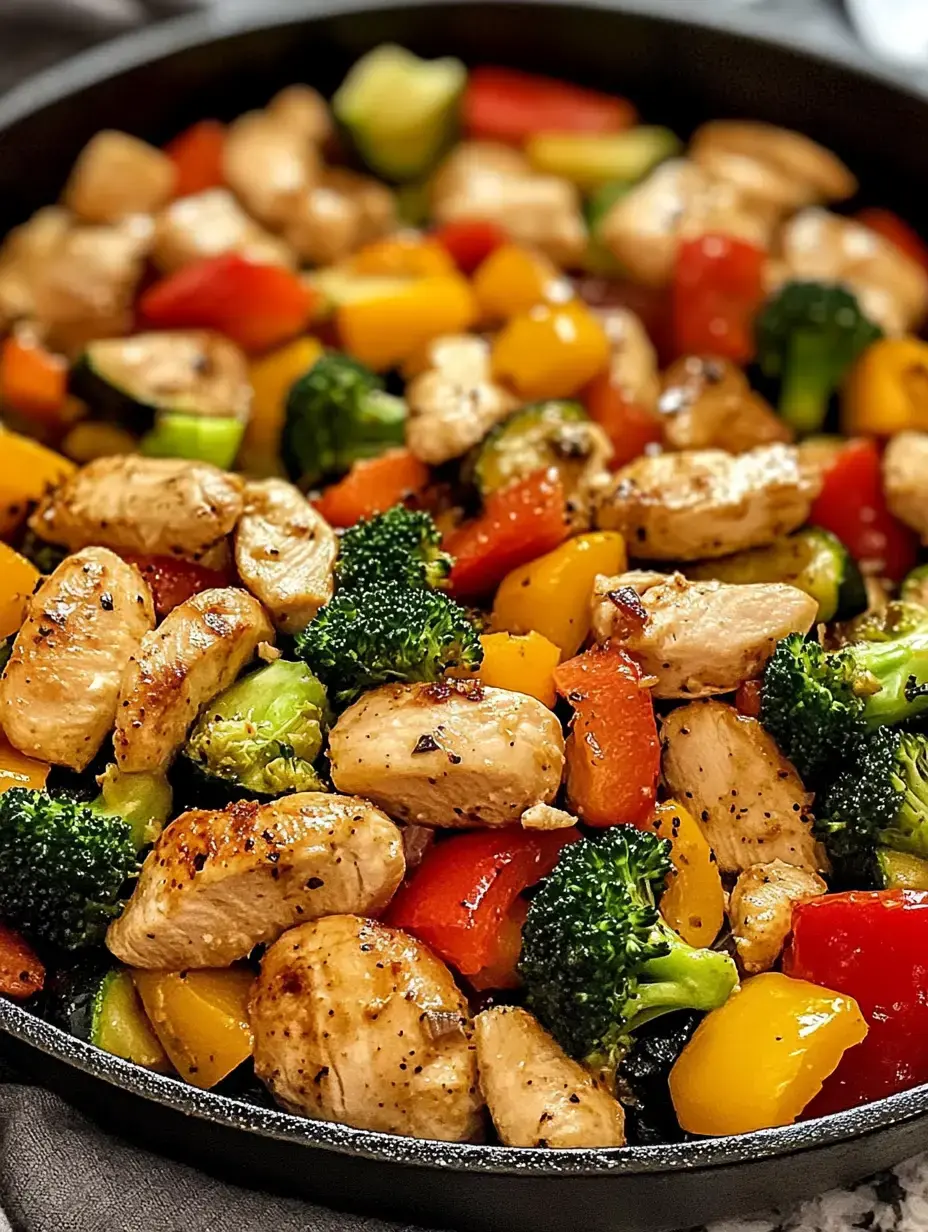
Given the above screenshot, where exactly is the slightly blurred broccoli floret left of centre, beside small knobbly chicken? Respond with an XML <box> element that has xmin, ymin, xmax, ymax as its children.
<box><xmin>281</xmin><ymin>352</ymin><xmax>405</xmax><ymax>488</ymax></box>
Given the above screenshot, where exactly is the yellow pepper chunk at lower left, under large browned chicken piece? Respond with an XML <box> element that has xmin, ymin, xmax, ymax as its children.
<box><xmin>132</xmin><ymin>967</ymin><xmax>254</xmax><ymax>1089</ymax></box>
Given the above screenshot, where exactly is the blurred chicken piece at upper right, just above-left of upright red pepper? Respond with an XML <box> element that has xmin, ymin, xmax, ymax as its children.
<box><xmin>599</xmin><ymin>159</ymin><xmax>776</xmax><ymax>287</ymax></box>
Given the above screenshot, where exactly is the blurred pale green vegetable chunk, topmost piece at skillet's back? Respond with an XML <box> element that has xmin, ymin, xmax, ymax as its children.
<box><xmin>332</xmin><ymin>43</ymin><xmax>467</xmax><ymax>180</ymax></box>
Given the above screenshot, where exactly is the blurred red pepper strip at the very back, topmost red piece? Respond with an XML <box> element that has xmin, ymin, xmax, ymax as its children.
<box><xmin>462</xmin><ymin>65</ymin><xmax>637</xmax><ymax>145</ymax></box>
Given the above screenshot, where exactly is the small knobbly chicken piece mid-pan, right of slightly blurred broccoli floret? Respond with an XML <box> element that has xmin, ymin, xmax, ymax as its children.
<box><xmin>405</xmin><ymin>334</ymin><xmax>519</xmax><ymax>466</ymax></box>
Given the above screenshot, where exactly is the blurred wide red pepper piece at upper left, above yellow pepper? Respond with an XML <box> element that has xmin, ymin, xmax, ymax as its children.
<box><xmin>139</xmin><ymin>253</ymin><xmax>315</xmax><ymax>351</ymax></box>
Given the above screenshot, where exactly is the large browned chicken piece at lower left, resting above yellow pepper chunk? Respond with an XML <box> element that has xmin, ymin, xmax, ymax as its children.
<box><xmin>106</xmin><ymin>791</ymin><xmax>405</xmax><ymax>971</ymax></box>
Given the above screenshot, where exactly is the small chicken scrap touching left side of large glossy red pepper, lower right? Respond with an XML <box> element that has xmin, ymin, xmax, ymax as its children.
<box><xmin>728</xmin><ymin>860</ymin><xmax>828</xmax><ymax>976</ymax></box>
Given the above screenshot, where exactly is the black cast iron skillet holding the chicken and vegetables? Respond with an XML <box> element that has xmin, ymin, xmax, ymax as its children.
<box><xmin>0</xmin><ymin>0</ymin><xmax>928</xmax><ymax>1232</ymax></box>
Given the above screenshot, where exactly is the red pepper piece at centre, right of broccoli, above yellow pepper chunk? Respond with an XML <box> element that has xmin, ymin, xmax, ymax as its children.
<box><xmin>445</xmin><ymin>471</ymin><xmax>569</xmax><ymax>599</ymax></box>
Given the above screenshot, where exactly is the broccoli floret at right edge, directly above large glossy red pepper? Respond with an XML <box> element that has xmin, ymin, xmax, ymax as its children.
<box><xmin>816</xmin><ymin>727</ymin><xmax>928</xmax><ymax>890</ymax></box>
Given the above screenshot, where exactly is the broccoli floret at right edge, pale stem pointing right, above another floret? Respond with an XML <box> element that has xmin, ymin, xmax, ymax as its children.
<box><xmin>760</xmin><ymin>630</ymin><xmax>928</xmax><ymax>786</ymax></box>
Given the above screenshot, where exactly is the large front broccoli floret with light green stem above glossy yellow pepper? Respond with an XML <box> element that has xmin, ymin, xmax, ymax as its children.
<box><xmin>519</xmin><ymin>825</ymin><xmax>738</xmax><ymax>1069</ymax></box>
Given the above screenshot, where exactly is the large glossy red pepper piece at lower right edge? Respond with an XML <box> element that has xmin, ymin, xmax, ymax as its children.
<box><xmin>783</xmin><ymin>890</ymin><xmax>928</xmax><ymax>1116</ymax></box>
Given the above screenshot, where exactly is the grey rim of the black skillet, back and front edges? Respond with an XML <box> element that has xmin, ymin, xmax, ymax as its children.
<box><xmin>0</xmin><ymin>0</ymin><xmax>928</xmax><ymax>1177</ymax></box>
